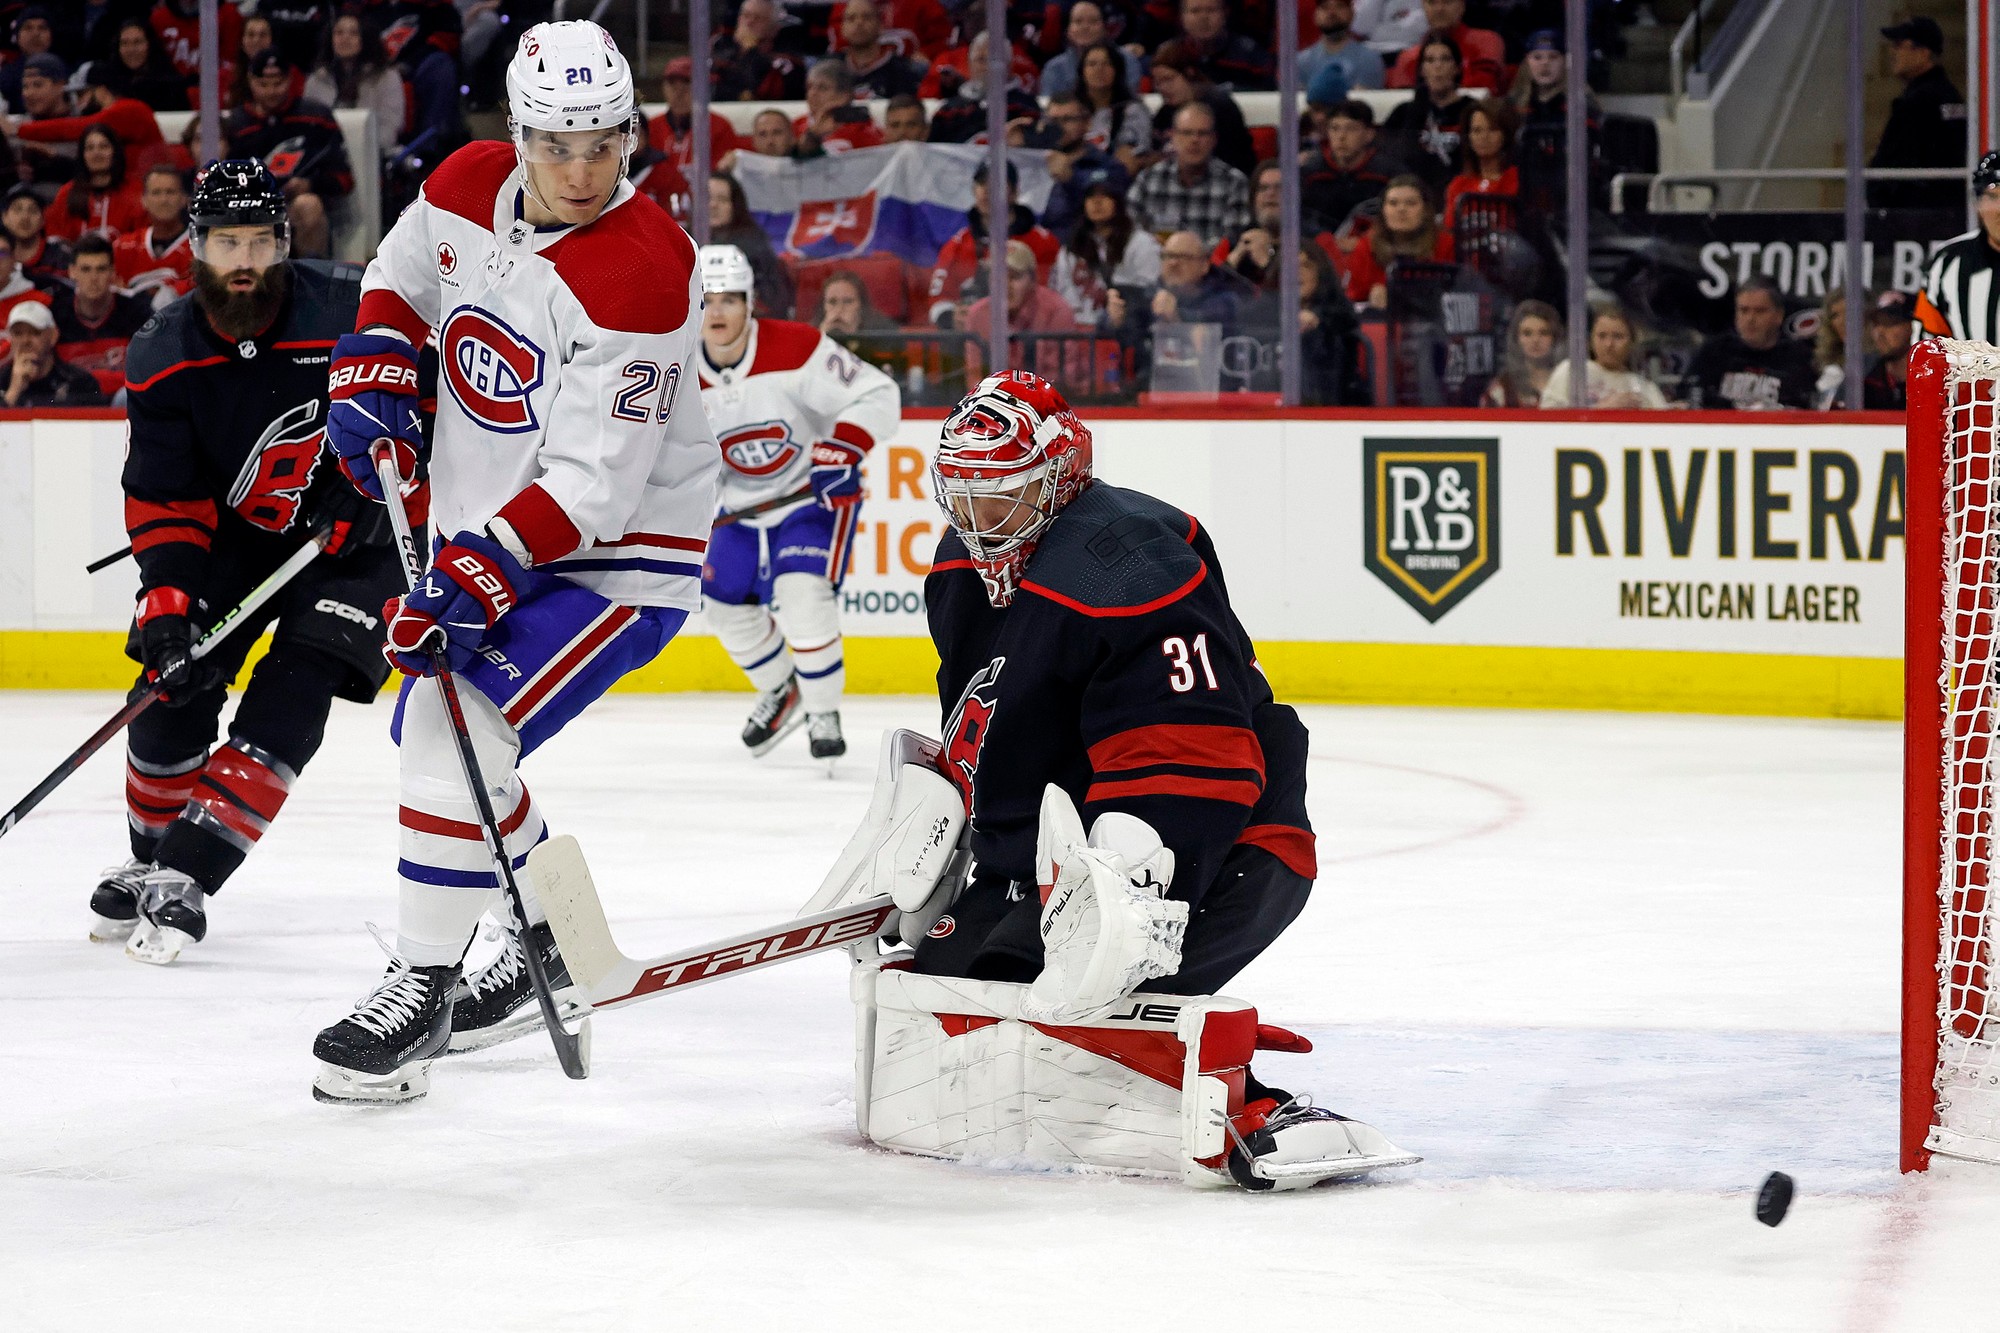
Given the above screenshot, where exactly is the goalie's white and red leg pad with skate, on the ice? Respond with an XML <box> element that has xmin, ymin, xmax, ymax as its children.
<box><xmin>850</xmin><ymin>957</ymin><xmax>1418</xmax><ymax>1191</ymax></box>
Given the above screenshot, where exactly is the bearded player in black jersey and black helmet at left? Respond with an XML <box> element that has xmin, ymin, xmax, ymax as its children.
<box><xmin>90</xmin><ymin>160</ymin><xmax>402</xmax><ymax>963</ymax></box>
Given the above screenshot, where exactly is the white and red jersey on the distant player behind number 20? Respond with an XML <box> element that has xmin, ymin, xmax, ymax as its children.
<box><xmin>700</xmin><ymin>320</ymin><xmax>902</xmax><ymax>526</ymax></box>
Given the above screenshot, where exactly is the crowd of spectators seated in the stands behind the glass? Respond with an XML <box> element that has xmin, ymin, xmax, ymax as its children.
<box><xmin>0</xmin><ymin>0</ymin><xmax>1948</xmax><ymax>408</ymax></box>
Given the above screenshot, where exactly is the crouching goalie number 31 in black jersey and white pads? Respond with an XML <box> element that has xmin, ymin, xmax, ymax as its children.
<box><xmin>808</xmin><ymin>372</ymin><xmax>1416</xmax><ymax>1189</ymax></box>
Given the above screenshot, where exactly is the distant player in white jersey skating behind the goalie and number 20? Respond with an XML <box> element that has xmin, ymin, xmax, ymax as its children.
<box><xmin>700</xmin><ymin>246</ymin><xmax>902</xmax><ymax>761</ymax></box>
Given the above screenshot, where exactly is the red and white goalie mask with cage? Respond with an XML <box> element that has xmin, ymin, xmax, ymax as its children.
<box><xmin>930</xmin><ymin>370</ymin><xmax>1090</xmax><ymax>606</ymax></box>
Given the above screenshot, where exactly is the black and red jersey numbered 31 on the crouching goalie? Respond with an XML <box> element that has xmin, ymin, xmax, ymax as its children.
<box><xmin>924</xmin><ymin>482</ymin><xmax>1316</xmax><ymax>905</ymax></box>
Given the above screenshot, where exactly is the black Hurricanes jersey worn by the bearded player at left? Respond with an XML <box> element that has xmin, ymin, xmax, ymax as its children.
<box><xmin>124</xmin><ymin>260</ymin><xmax>362</xmax><ymax>588</ymax></box>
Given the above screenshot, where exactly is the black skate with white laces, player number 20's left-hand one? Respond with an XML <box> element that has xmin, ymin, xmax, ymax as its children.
<box><xmin>312</xmin><ymin>955</ymin><xmax>458</xmax><ymax>1103</ymax></box>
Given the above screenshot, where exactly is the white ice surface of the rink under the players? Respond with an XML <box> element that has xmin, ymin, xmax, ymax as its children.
<box><xmin>0</xmin><ymin>695</ymin><xmax>2000</xmax><ymax>1333</ymax></box>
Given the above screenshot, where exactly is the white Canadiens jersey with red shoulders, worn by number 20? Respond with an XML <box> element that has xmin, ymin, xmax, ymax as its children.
<box><xmin>356</xmin><ymin>142</ymin><xmax>718</xmax><ymax>610</ymax></box>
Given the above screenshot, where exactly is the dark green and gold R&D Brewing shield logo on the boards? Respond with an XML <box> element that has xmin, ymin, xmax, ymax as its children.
<box><xmin>1362</xmin><ymin>440</ymin><xmax>1500</xmax><ymax>620</ymax></box>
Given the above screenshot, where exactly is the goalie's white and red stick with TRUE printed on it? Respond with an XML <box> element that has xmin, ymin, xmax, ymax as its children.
<box><xmin>528</xmin><ymin>835</ymin><xmax>896</xmax><ymax>1009</ymax></box>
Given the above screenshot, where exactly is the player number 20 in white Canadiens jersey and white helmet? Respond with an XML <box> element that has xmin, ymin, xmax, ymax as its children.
<box><xmin>314</xmin><ymin>22</ymin><xmax>718</xmax><ymax>1101</ymax></box>
